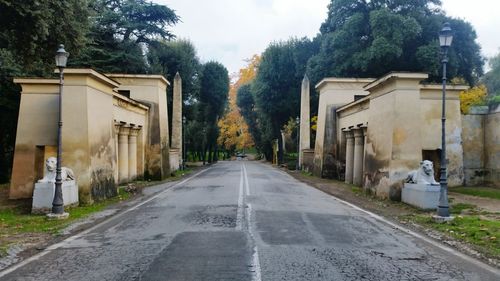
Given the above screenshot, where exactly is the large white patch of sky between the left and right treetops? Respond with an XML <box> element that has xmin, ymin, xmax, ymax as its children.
<box><xmin>155</xmin><ymin>0</ymin><xmax>329</xmax><ymax>73</ymax></box>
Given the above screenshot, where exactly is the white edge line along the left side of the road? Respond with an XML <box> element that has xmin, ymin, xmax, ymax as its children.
<box><xmin>0</xmin><ymin>165</ymin><xmax>211</xmax><ymax>278</ymax></box>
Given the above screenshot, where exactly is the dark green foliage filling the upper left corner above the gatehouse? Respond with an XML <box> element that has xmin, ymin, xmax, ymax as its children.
<box><xmin>0</xmin><ymin>0</ymin><xmax>89</xmax><ymax>73</ymax></box>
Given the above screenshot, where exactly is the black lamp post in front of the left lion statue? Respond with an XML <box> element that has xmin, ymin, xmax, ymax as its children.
<box><xmin>52</xmin><ymin>44</ymin><xmax>69</xmax><ymax>215</ymax></box>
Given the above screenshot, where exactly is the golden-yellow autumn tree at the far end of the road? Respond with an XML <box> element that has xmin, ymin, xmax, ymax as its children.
<box><xmin>217</xmin><ymin>55</ymin><xmax>260</xmax><ymax>151</ymax></box>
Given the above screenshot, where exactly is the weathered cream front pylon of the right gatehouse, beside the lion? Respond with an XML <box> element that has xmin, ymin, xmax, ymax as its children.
<box><xmin>364</xmin><ymin>73</ymin><xmax>427</xmax><ymax>198</ymax></box>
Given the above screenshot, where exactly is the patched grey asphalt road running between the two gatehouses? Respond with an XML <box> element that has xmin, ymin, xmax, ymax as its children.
<box><xmin>0</xmin><ymin>161</ymin><xmax>500</xmax><ymax>281</ymax></box>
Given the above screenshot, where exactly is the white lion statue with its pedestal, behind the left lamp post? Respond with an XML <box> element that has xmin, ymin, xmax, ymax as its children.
<box><xmin>31</xmin><ymin>157</ymin><xmax>78</xmax><ymax>214</ymax></box>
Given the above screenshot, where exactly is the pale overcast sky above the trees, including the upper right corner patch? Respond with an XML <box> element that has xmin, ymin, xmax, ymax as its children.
<box><xmin>158</xmin><ymin>0</ymin><xmax>500</xmax><ymax>73</ymax></box>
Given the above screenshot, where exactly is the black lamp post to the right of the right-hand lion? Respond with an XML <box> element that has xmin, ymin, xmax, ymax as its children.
<box><xmin>437</xmin><ymin>23</ymin><xmax>453</xmax><ymax>218</ymax></box>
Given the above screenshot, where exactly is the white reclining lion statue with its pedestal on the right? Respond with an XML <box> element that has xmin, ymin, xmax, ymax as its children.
<box><xmin>401</xmin><ymin>160</ymin><xmax>441</xmax><ymax>210</ymax></box>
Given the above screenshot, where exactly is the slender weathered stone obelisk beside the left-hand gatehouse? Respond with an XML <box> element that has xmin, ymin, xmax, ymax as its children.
<box><xmin>172</xmin><ymin>72</ymin><xmax>183</xmax><ymax>167</ymax></box>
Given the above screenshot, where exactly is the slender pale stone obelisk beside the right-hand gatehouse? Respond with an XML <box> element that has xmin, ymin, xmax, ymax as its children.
<box><xmin>299</xmin><ymin>75</ymin><xmax>311</xmax><ymax>167</ymax></box>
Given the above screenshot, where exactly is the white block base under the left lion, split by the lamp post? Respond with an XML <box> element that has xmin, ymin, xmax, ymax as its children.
<box><xmin>31</xmin><ymin>181</ymin><xmax>78</xmax><ymax>214</ymax></box>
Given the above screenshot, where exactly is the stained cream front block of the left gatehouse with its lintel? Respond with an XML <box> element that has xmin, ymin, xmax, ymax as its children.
<box><xmin>10</xmin><ymin>69</ymin><xmax>148</xmax><ymax>203</ymax></box>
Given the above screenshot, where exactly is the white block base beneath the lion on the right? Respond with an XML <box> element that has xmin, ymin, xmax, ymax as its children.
<box><xmin>401</xmin><ymin>183</ymin><xmax>441</xmax><ymax>210</ymax></box>
